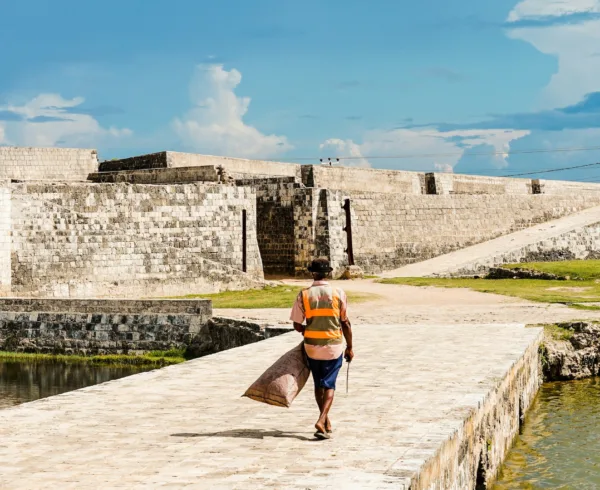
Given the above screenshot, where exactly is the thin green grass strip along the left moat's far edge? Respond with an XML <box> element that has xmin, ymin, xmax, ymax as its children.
<box><xmin>0</xmin><ymin>349</ymin><xmax>185</xmax><ymax>367</ymax></box>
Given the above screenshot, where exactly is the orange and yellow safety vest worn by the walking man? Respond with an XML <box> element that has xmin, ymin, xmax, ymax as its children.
<box><xmin>302</xmin><ymin>286</ymin><xmax>343</xmax><ymax>345</ymax></box>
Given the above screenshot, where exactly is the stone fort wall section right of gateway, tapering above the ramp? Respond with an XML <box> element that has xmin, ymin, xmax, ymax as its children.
<box><xmin>324</xmin><ymin>191</ymin><xmax>600</xmax><ymax>272</ymax></box>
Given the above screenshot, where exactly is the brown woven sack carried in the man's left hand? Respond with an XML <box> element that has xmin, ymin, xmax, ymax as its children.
<box><xmin>243</xmin><ymin>343</ymin><xmax>310</xmax><ymax>407</ymax></box>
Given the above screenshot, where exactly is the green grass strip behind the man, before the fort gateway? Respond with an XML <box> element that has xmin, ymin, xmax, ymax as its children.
<box><xmin>170</xmin><ymin>286</ymin><xmax>378</xmax><ymax>309</ymax></box>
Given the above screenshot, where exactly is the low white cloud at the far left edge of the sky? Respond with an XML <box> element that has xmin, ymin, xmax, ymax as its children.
<box><xmin>0</xmin><ymin>94</ymin><xmax>132</xmax><ymax>146</ymax></box>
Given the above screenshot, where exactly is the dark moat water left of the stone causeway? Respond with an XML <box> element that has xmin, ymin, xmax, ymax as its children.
<box><xmin>0</xmin><ymin>361</ymin><xmax>153</xmax><ymax>409</ymax></box>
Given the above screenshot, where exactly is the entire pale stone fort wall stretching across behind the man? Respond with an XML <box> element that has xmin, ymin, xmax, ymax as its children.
<box><xmin>5</xmin><ymin>149</ymin><xmax>600</xmax><ymax>290</ymax></box>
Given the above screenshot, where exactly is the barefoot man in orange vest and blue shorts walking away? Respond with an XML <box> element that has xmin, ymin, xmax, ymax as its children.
<box><xmin>290</xmin><ymin>259</ymin><xmax>354</xmax><ymax>439</ymax></box>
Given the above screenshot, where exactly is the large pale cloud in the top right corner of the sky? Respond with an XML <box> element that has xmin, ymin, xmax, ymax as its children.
<box><xmin>508</xmin><ymin>0</ymin><xmax>600</xmax><ymax>109</ymax></box>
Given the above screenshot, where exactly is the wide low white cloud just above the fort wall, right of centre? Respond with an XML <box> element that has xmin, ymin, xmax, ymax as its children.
<box><xmin>320</xmin><ymin>128</ymin><xmax>530</xmax><ymax>172</ymax></box>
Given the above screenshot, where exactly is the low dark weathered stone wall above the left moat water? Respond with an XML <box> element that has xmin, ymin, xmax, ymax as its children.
<box><xmin>0</xmin><ymin>298</ymin><xmax>212</xmax><ymax>354</ymax></box>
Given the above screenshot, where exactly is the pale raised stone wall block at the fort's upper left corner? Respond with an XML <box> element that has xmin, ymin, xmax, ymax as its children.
<box><xmin>0</xmin><ymin>146</ymin><xmax>98</xmax><ymax>181</ymax></box>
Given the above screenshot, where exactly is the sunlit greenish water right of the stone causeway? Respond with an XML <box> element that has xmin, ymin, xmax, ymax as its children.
<box><xmin>493</xmin><ymin>378</ymin><xmax>600</xmax><ymax>490</ymax></box>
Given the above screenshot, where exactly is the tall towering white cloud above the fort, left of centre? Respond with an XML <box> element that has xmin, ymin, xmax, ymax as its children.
<box><xmin>173</xmin><ymin>65</ymin><xmax>292</xmax><ymax>158</ymax></box>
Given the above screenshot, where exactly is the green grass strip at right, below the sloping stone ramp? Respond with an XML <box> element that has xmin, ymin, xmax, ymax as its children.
<box><xmin>380</xmin><ymin>277</ymin><xmax>600</xmax><ymax>309</ymax></box>
